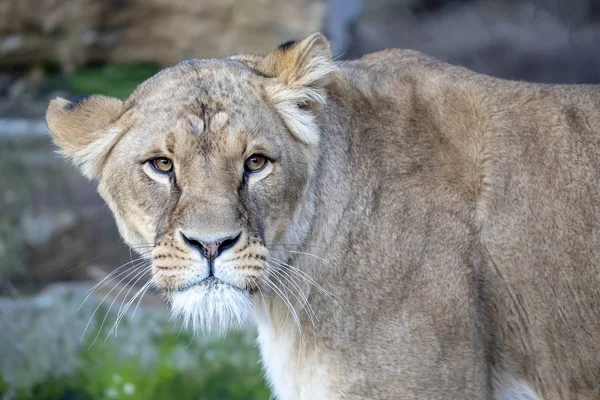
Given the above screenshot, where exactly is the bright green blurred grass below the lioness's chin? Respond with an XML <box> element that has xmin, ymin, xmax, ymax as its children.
<box><xmin>16</xmin><ymin>333</ymin><xmax>269</xmax><ymax>400</ymax></box>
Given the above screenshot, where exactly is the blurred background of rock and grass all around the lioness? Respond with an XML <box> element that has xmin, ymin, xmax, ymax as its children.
<box><xmin>0</xmin><ymin>0</ymin><xmax>600</xmax><ymax>400</ymax></box>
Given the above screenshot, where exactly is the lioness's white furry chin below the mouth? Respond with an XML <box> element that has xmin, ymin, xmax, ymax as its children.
<box><xmin>170</xmin><ymin>281</ymin><xmax>252</xmax><ymax>335</ymax></box>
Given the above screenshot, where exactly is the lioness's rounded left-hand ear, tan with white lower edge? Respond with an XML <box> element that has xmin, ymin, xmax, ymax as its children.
<box><xmin>46</xmin><ymin>95</ymin><xmax>123</xmax><ymax>179</ymax></box>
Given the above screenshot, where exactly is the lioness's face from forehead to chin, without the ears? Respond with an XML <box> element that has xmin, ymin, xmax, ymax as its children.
<box><xmin>100</xmin><ymin>62</ymin><xmax>314</xmax><ymax>332</ymax></box>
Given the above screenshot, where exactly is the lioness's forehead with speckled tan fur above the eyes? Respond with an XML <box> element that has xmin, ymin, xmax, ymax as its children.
<box><xmin>120</xmin><ymin>60</ymin><xmax>272</xmax><ymax>158</ymax></box>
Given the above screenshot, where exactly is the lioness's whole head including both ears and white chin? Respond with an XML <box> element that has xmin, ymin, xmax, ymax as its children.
<box><xmin>47</xmin><ymin>34</ymin><xmax>335</xmax><ymax>329</ymax></box>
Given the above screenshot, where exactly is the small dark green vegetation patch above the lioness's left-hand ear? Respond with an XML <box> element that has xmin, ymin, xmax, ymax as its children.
<box><xmin>67</xmin><ymin>64</ymin><xmax>160</xmax><ymax>99</ymax></box>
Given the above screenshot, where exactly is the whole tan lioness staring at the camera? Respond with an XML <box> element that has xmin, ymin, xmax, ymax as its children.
<box><xmin>47</xmin><ymin>33</ymin><xmax>600</xmax><ymax>400</ymax></box>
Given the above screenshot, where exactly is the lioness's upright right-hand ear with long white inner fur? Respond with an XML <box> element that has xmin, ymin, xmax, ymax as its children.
<box><xmin>257</xmin><ymin>32</ymin><xmax>337</xmax><ymax>145</ymax></box>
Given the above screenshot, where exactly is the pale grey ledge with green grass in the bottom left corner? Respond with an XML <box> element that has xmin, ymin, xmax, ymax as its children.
<box><xmin>0</xmin><ymin>290</ymin><xmax>270</xmax><ymax>400</ymax></box>
